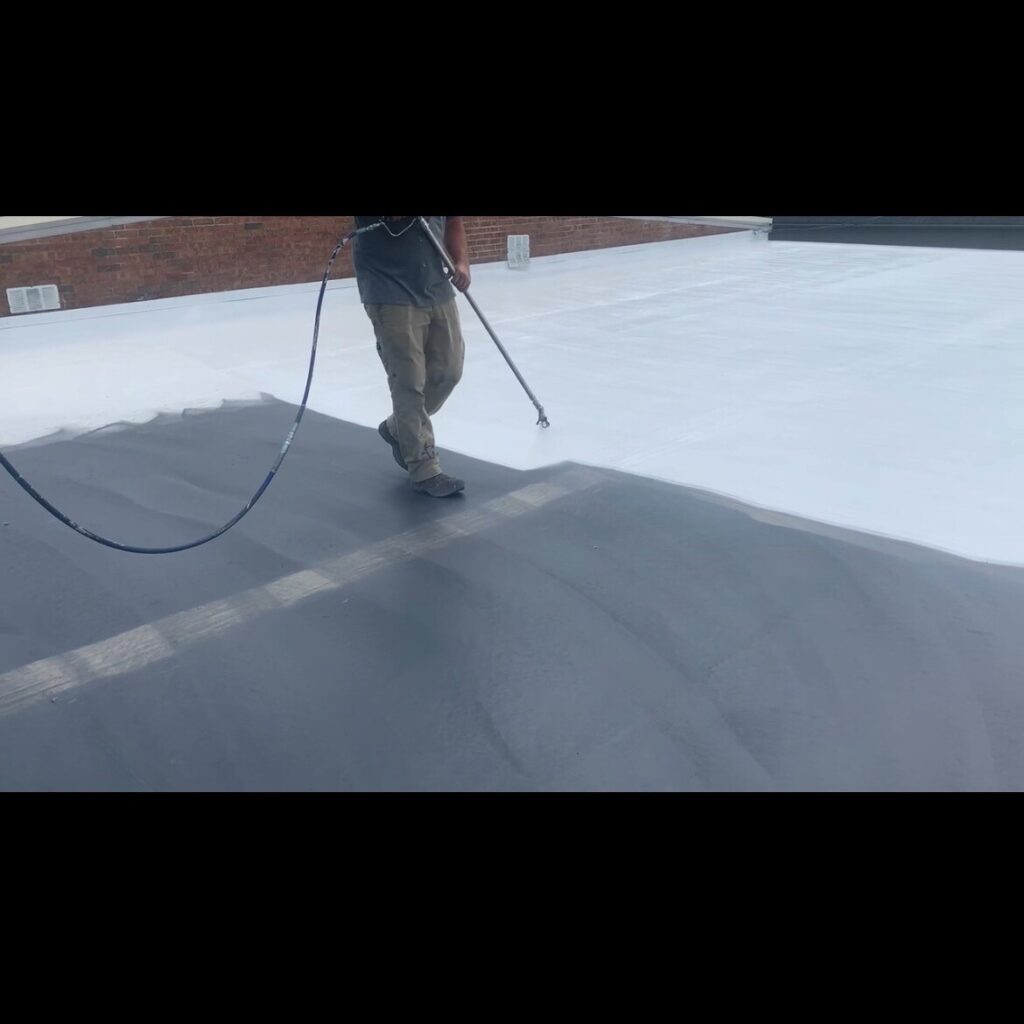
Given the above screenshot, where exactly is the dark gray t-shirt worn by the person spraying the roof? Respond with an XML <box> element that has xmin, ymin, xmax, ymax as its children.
<box><xmin>352</xmin><ymin>217</ymin><xmax>455</xmax><ymax>307</ymax></box>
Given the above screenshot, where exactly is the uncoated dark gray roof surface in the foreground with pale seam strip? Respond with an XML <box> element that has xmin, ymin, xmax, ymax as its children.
<box><xmin>0</xmin><ymin>402</ymin><xmax>1024</xmax><ymax>791</ymax></box>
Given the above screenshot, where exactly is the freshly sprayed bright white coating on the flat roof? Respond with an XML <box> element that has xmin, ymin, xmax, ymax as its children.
<box><xmin>0</xmin><ymin>232</ymin><xmax>1024</xmax><ymax>564</ymax></box>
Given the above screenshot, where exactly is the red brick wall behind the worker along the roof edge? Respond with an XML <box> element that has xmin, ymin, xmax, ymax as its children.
<box><xmin>0</xmin><ymin>217</ymin><xmax>737</xmax><ymax>315</ymax></box>
